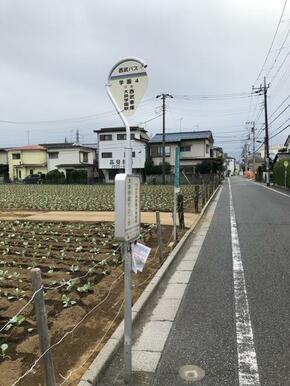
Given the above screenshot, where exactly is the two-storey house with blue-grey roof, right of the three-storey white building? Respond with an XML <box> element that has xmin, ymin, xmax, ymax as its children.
<box><xmin>149</xmin><ymin>130</ymin><xmax>214</xmax><ymax>173</ymax></box>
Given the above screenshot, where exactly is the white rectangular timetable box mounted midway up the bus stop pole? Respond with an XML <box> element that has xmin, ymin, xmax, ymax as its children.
<box><xmin>115</xmin><ymin>173</ymin><xmax>140</xmax><ymax>241</ymax></box>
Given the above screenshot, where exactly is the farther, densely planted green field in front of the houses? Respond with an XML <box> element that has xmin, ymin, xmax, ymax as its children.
<box><xmin>0</xmin><ymin>184</ymin><xmax>194</xmax><ymax>212</ymax></box>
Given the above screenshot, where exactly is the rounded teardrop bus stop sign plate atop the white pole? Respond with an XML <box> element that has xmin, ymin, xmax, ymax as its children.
<box><xmin>109</xmin><ymin>58</ymin><xmax>148</xmax><ymax>116</ymax></box>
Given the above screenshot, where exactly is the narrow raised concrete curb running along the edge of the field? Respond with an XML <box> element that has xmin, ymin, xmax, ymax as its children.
<box><xmin>78</xmin><ymin>185</ymin><xmax>222</xmax><ymax>386</ymax></box>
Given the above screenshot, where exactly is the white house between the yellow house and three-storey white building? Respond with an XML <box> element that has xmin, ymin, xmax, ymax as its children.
<box><xmin>41</xmin><ymin>142</ymin><xmax>97</xmax><ymax>181</ymax></box>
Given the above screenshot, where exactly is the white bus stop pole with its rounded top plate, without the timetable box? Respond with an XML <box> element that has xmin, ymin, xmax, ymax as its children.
<box><xmin>106</xmin><ymin>58</ymin><xmax>147</xmax><ymax>383</ymax></box>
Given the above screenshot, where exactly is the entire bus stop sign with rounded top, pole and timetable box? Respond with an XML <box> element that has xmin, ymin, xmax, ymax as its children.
<box><xmin>106</xmin><ymin>57</ymin><xmax>148</xmax><ymax>384</ymax></box>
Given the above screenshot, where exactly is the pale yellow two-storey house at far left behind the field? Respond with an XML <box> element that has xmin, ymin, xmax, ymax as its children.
<box><xmin>8</xmin><ymin>145</ymin><xmax>47</xmax><ymax>181</ymax></box>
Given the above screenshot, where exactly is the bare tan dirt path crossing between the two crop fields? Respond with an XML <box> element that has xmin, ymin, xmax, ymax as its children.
<box><xmin>0</xmin><ymin>211</ymin><xmax>198</xmax><ymax>228</ymax></box>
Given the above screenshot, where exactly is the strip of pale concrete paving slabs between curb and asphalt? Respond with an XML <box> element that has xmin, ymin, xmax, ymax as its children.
<box><xmin>98</xmin><ymin>186</ymin><xmax>220</xmax><ymax>386</ymax></box>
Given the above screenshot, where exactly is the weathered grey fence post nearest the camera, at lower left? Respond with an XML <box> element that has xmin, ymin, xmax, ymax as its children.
<box><xmin>31</xmin><ymin>268</ymin><xmax>56</xmax><ymax>386</ymax></box>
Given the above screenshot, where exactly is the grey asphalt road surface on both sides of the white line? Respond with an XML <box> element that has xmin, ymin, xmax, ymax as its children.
<box><xmin>154</xmin><ymin>177</ymin><xmax>290</xmax><ymax>386</ymax></box>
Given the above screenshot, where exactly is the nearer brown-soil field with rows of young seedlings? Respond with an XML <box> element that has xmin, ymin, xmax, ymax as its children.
<box><xmin>0</xmin><ymin>221</ymin><xmax>177</xmax><ymax>386</ymax></box>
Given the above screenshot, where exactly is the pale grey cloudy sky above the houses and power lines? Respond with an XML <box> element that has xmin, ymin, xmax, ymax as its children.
<box><xmin>0</xmin><ymin>0</ymin><xmax>290</xmax><ymax>155</ymax></box>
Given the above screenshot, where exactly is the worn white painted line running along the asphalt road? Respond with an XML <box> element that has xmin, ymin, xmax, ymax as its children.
<box><xmin>228</xmin><ymin>178</ymin><xmax>260</xmax><ymax>386</ymax></box>
